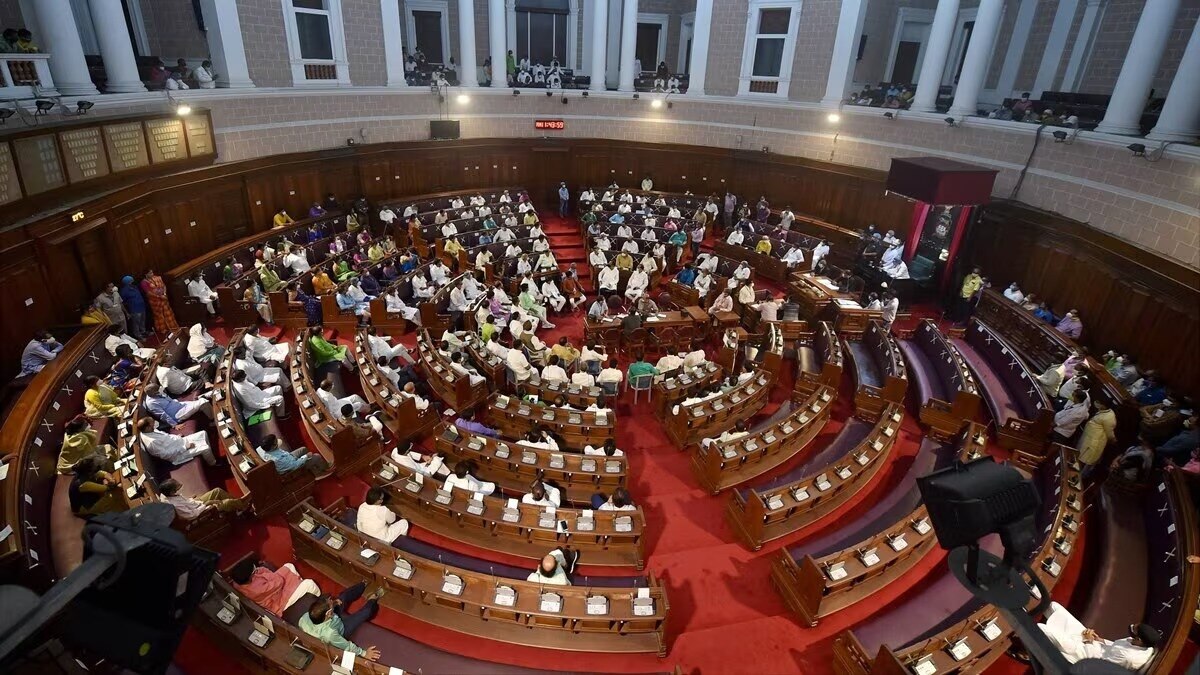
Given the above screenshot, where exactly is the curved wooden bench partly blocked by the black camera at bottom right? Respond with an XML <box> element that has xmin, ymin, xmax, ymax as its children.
<box><xmin>833</xmin><ymin>446</ymin><xmax>1082</xmax><ymax>675</ymax></box>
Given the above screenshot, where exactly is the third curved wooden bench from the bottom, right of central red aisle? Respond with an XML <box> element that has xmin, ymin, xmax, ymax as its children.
<box><xmin>725</xmin><ymin>404</ymin><xmax>904</xmax><ymax>550</ymax></box>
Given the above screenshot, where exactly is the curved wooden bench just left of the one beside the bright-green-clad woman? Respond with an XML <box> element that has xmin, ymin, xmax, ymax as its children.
<box><xmin>212</xmin><ymin>329</ymin><xmax>319</xmax><ymax>518</ymax></box>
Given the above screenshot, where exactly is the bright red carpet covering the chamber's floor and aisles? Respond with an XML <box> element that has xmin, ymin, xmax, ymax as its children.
<box><xmin>176</xmin><ymin>211</ymin><xmax>1113</xmax><ymax>675</ymax></box>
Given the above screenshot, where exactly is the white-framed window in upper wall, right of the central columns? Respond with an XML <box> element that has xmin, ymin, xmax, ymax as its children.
<box><xmin>739</xmin><ymin>0</ymin><xmax>800</xmax><ymax>96</ymax></box>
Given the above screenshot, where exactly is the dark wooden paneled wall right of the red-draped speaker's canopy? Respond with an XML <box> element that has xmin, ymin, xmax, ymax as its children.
<box><xmin>964</xmin><ymin>202</ymin><xmax>1200</xmax><ymax>395</ymax></box>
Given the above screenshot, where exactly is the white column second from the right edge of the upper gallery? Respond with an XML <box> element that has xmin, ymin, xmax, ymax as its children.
<box><xmin>1099</xmin><ymin>0</ymin><xmax>1180</xmax><ymax>135</ymax></box>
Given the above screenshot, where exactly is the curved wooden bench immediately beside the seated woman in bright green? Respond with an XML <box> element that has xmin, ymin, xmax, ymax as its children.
<box><xmin>290</xmin><ymin>328</ymin><xmax>379</xmax><ymax>477</ymax></box>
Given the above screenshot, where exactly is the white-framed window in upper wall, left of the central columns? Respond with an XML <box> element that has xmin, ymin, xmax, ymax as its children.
<box><xmin>282</xmin><ymin>0</ymin><xmax>350</xmax><ymax>86</ymax></box>
